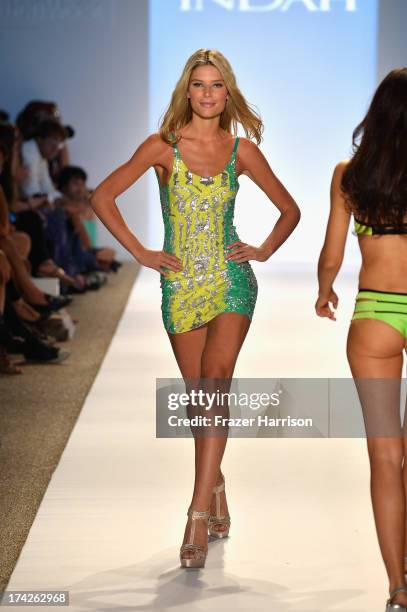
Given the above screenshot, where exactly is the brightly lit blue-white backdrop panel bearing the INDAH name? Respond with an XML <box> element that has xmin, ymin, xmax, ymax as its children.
<box><xmin>150</xmin><ymin>0</ymin><xmax>377</xmax><ymax>262</ymax></box>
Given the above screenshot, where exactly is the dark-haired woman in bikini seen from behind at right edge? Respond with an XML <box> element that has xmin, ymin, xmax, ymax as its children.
<box><xmin>315</xmin><ymin>68</ymin><xmax>407</xmax><ymax>612</ymax></box>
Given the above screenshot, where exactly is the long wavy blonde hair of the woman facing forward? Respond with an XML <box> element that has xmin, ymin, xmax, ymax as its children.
<box><xmin>159</xmin><ymin>49</ymin><xmax>264</xmax><ymax>144</ymax></box>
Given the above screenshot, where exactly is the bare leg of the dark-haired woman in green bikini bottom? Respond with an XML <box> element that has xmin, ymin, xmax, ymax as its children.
<box><xmin>348</xmin><ymin>319</ymin><xmax>407</xmax><ymax>605</ymax></box>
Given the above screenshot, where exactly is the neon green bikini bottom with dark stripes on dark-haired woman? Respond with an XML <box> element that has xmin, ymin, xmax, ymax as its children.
<box><xmin>352</xmin><ymin>289</ymin><xmax>407</xmax><ymax>338</ymax></box>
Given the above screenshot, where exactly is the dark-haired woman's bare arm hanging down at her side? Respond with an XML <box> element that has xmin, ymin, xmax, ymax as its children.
<box><xmin>315</xmin><ymin>161</ymin><xmax>350</xmax><ymax>321</ymax></box>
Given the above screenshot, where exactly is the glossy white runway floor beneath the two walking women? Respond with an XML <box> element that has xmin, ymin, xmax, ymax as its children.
<box><xmin>8</xmin><ymin>262</ymin><xmax>387</xmax><ymax>612</ymax></box>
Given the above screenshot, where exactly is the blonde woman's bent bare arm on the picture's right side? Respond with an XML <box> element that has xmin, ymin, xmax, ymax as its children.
<box><xmin>227</xmin><ymin>138</ymin><xmax>301</xmax><ymax>263</ymax></box>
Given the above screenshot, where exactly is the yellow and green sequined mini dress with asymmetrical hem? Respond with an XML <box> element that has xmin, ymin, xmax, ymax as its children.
<box><xmin>156</xmin><ymin>137</ymin><xmax>258</xmax><ymax>334</ymax></box>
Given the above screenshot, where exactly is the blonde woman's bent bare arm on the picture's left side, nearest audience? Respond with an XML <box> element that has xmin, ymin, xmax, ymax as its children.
<box><xmin>90</xmin><ymin>134</ymin><xmax>181</xmax><ymax>276</ymax></box>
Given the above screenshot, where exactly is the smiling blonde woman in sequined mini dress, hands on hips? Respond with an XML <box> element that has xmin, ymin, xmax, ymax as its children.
<box><xmin>91</xmin><ymin>49</ymin><xmax>300</xmax><ymax>567</ymax></box>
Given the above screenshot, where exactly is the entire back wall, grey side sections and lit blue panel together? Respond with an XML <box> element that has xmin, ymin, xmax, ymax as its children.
<box><xmin>0</xmin><ymin>0</ymin><xmax>407</xmax><ymax>263</ymax></box>
